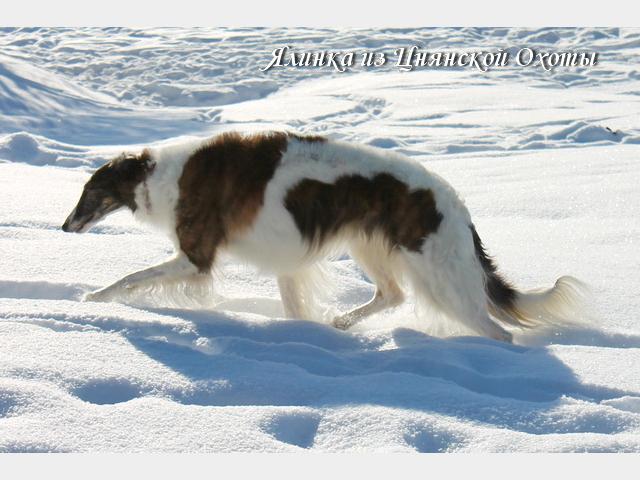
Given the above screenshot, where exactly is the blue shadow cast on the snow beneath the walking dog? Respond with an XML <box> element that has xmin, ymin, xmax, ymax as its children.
<box><xmin>117</xmin><ymin>302</ymin><xmax>640</xmax><ymax>433</ymax></box>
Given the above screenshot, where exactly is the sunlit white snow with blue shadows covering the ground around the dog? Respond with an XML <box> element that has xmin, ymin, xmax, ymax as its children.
<box><xmin>0</xmin><ymin>28</ymin><xmax>640</xmax><ymax>452</ymax></box>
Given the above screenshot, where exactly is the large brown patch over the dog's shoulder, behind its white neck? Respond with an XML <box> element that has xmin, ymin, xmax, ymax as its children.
<box><xmin>176</xmin><ymin>132</ymin><xmax>288</xmax><ymax>271</ymax></box>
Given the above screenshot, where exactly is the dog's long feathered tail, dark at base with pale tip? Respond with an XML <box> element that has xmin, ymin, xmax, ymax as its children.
<box><xmin>470</xmin><ymin>225</ymin><xmax>589</xmax><ymax>328</ymax></box>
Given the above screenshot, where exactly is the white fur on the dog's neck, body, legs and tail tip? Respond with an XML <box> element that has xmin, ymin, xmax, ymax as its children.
<box><xmin>87</xmin><ymin>133</ymin><xmax>592</xmax><ymax>340</ymax></box>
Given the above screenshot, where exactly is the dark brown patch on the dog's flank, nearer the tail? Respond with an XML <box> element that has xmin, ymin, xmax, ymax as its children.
<box><xmin>285</xmin><ymin>173</ymin><xmax>442</xmax><ymax>252</ymax></box>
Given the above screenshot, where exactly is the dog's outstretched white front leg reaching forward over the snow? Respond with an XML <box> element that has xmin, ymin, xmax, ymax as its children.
<box><xmin>83</xmin><ymin>252</ymin><xmax>198</xmax><ymax>302</ymax></box>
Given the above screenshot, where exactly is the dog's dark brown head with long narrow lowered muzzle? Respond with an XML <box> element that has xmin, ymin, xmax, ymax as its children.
<box><xmin>62</xmin><ymin>150</ymin><xmax>153</xmax><ymax>233</ymax></box>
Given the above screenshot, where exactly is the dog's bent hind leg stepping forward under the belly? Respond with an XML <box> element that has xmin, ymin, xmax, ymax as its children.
<box><xmin>333</xmin><ymin>242</ymin><xmax>404</xmax><ymax>330</ymax></box>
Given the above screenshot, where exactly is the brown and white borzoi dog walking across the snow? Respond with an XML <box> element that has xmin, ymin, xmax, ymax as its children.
<box><xmin>62</xmin><ymin>132</ymin><xmax>581</xmax><ymax>342</ymax></box>
